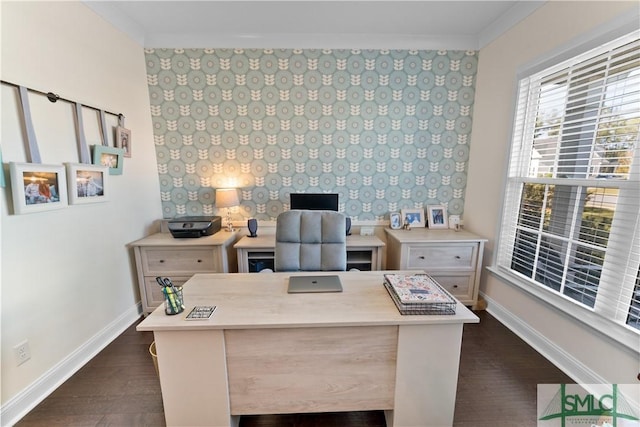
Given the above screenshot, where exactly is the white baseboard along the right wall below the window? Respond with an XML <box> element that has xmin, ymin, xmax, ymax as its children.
<box><xmin>481</xmin><ymin>293</ymin><xmax>607</xmax><ymax>384</ymax></box>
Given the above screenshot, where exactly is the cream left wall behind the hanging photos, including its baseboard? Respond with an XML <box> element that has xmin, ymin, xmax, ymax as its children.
<box><xmin>0</xmin><ymin>1</ymin><xmax>162</xmax><ymax>425</ymax></box>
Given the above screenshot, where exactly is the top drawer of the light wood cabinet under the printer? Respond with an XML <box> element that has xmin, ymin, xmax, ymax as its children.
<box><xmin>142</xmin><ymin>248</ymin><xmax>216</xmax><ymax>275</ymax></box>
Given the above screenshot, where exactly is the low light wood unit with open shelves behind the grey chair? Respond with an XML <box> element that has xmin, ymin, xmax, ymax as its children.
<box><xmin>234</xmin><ymin>235</ymin><xmax>384</xmax><ymax>273</ymax></box>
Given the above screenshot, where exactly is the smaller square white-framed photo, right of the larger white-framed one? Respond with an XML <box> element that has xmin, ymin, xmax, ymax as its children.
<box><xmin>67</xmin><ymin>163</ymin><xmax>109</xmax><ymax>205</ymax></box>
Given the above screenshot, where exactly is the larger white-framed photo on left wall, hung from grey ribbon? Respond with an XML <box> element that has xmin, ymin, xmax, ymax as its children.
<box><xmin>9</xmin><ymin>162</ymin><xmax>68</xmax><ymax>214</ymax></box>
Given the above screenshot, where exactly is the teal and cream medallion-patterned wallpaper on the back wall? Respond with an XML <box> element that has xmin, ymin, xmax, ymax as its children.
<box><xmin>145</xmin><ymin>49</ymin><xmax>478</xmax><ymax>220</ymax></box>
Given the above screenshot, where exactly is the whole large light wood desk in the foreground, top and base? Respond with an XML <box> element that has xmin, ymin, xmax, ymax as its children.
<box><xmin>137</xmin><ymin>271</ymin><xmax>479</xmax><ymax>427</ymax></box>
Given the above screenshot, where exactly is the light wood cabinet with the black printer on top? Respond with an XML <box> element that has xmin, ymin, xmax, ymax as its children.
<box><xmin>129</xmin><ymin>231</ymin><xmax>237</xmax><ymax>315</ymax></box>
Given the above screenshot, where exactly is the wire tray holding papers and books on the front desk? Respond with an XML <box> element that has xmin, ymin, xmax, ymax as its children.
<box><xmin>384</xmin><ymin>274</ymin><xmax>456</xmax><ymax>315</ymax></box>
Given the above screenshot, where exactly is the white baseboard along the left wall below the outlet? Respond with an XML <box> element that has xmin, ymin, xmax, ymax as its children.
<box><xmin>0</xmin><ymin>303</ymin><xmax>142</xmax><ymax>427</ymax></box>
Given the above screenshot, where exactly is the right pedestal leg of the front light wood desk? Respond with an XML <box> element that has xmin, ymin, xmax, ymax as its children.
<box><xmin>386</xmin><ymin>324</ymin><xmax>463</xmax><ymax>427</ymax></box>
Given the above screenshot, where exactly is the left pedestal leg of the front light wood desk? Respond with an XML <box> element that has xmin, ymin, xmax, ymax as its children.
<box><xmin>154</xmin><ymin>330</ymin><xmax>232</xmax><ymax>427</ymax></box>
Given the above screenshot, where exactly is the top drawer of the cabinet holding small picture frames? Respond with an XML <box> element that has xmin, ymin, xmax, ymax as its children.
<box><xmin>407</xmin><ymin>244</ymin><xmax>476</xmax><ymax>270</ymax></box>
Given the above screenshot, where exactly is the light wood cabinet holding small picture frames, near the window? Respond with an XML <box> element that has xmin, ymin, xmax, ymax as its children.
<box><xmin>385</xmin><ymin>229</ymin><xmax>486</xmax><ymax>308</ymax></box>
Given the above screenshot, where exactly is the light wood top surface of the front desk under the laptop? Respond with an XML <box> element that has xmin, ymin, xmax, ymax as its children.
<box><xmin>137</xmin><ymin>271</ymin><xmax>479</xmax><ymax>331</ymax></box>
